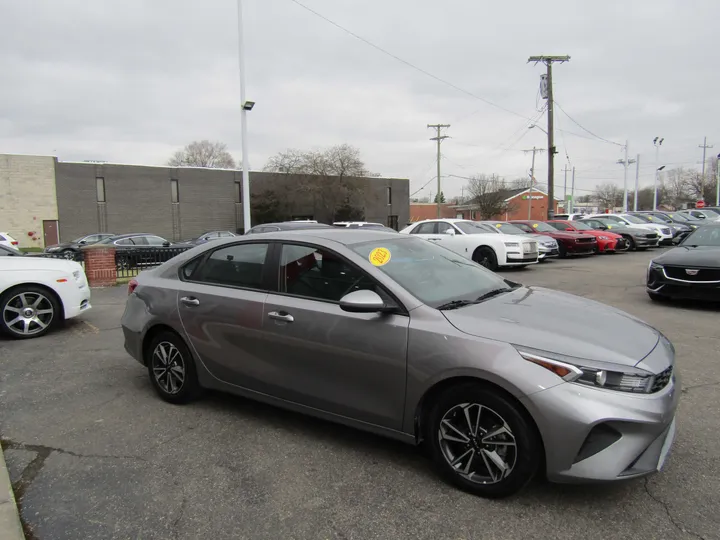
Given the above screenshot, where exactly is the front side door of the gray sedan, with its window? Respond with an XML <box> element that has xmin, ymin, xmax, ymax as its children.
<box><xmin>260</xmin><ymin>243</ymin><xmax>410</xmax><ymax>430</ymax></box>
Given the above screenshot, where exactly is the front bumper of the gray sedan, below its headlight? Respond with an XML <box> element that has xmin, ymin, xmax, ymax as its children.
<box><xmin>523</xmin><ymin>373</ymin><xmax>680</xmax><ymax>483</ymax></box>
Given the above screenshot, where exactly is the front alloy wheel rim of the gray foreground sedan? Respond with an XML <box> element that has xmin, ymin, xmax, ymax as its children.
<box><xmin>437</xmin><ymin>403</ymin><xmax>517</xmax><ymax>484</ymax></box>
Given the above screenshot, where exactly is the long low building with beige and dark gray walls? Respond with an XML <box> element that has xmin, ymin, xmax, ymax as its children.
<box><xmin>0</xmin><ymin>155</ymin><xmax>410</xmax><ymax>247</ymax></box>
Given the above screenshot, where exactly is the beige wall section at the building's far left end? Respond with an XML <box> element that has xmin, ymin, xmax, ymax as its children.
<box><xmin>0</xmin><ymin>154</ymin><xmax>58</xmax><ymax>248</ymax></box>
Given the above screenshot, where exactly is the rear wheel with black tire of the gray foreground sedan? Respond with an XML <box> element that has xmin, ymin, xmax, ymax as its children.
<box><xmin>145</xmin><ymin>331</ymin><xmax>202</xmax><ymax>404</ymax></box>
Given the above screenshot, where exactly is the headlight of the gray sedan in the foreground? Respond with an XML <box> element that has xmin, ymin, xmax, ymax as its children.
<box><xmin>516</xmin><ymin>347</ymin><xmax>656</xmax><ymax>394</ymax></box>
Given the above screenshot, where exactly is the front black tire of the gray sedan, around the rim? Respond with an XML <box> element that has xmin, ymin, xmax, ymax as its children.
<box><xmin>422</xmin><ymin>382</ymin><xmax>543</xmax><ymax>498</ymax></box>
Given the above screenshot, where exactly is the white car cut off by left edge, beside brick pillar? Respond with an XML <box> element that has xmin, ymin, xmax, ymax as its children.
<box><xmin>0</xmin><ymin>250</ymin><xmax>91</xmax><ymax>339</ymax></box>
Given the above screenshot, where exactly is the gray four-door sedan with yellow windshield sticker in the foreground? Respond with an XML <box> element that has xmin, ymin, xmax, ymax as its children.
<box><xmin>122</xmin><ymin>229</ymin><xmax>680</xmax><ymax>497</ymax></box>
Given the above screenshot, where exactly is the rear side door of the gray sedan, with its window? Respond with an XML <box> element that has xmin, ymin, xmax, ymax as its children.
<box><xmin>177</xmin><ymin>242</ymin><xmax>272</xmax><ymax>391</ymax></box>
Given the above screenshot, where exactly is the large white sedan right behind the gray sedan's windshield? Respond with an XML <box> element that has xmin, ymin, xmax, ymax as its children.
<box><xmin>400</xmin><ymin>219</ymin><xmax>538</xmax><ymax>270</ymax></box>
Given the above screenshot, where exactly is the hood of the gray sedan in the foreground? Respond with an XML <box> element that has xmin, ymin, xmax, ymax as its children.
<box><xmin>442</xmin><ymin>287</ymin><xmax>660</xmax><ymax>366</ymax></box>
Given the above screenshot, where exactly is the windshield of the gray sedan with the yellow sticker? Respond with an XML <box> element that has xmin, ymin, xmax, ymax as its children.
<box><xmin>348</xmin><ymin>237</ymin><xmax>512</xmax><ymax>308</ymax></box>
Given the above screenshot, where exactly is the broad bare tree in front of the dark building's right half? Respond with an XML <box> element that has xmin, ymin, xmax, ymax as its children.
<box><xmin>265</xmin><ymin>144</ymin><xmax>377</xmax><ymax>221</ymax></box>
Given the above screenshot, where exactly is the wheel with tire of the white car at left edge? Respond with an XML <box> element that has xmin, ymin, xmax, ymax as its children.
<box><xmin>0</xmin><ymin>285</ymin><xmax>63</xmax><ymax>339</ymax></box>
